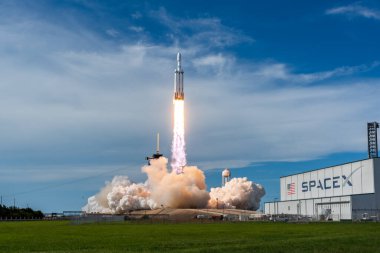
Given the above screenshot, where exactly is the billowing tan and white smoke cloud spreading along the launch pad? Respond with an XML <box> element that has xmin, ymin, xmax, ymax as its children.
<box><xmin>82</xmin><ymin>157</ymin><xmax>264</xmax><ymax>213</ymax></box>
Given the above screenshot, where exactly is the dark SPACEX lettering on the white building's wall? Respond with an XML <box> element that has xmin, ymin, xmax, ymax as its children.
<box><xmin>301</xmin><ymin>166</ymin><xmax>362</xmax><ymax>192</ymax></box>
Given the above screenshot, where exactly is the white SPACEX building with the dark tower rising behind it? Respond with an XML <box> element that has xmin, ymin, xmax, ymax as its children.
<box><xmin>264</xmin><ymin>122</ymin><xmax>380</xmax><ymax>220</ymax></box>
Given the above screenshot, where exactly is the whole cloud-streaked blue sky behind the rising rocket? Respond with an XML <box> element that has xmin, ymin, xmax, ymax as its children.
<box><xmin>0</xmin><ymin>0</ymin><xmax>380</xmax><ymax>212</ymax></box>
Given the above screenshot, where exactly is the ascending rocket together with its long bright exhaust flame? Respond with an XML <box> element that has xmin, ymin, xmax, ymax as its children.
<box><xmin>171</xmin><ymin>53</ymin><xmax>187</xmax><ymax>174</ymax></box>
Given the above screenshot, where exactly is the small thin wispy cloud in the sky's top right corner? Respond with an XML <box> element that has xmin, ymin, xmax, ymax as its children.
<box><xmin>326</xmin><ymin>3</ymin><xmax>380</xmax><ymax>20</ymax></box>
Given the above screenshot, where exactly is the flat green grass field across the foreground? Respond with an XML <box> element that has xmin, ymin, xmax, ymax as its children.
<box><xmin>0</xmin><ymin>221</ymin><xmax>380</xmax><ymax>253</ymax></box>
